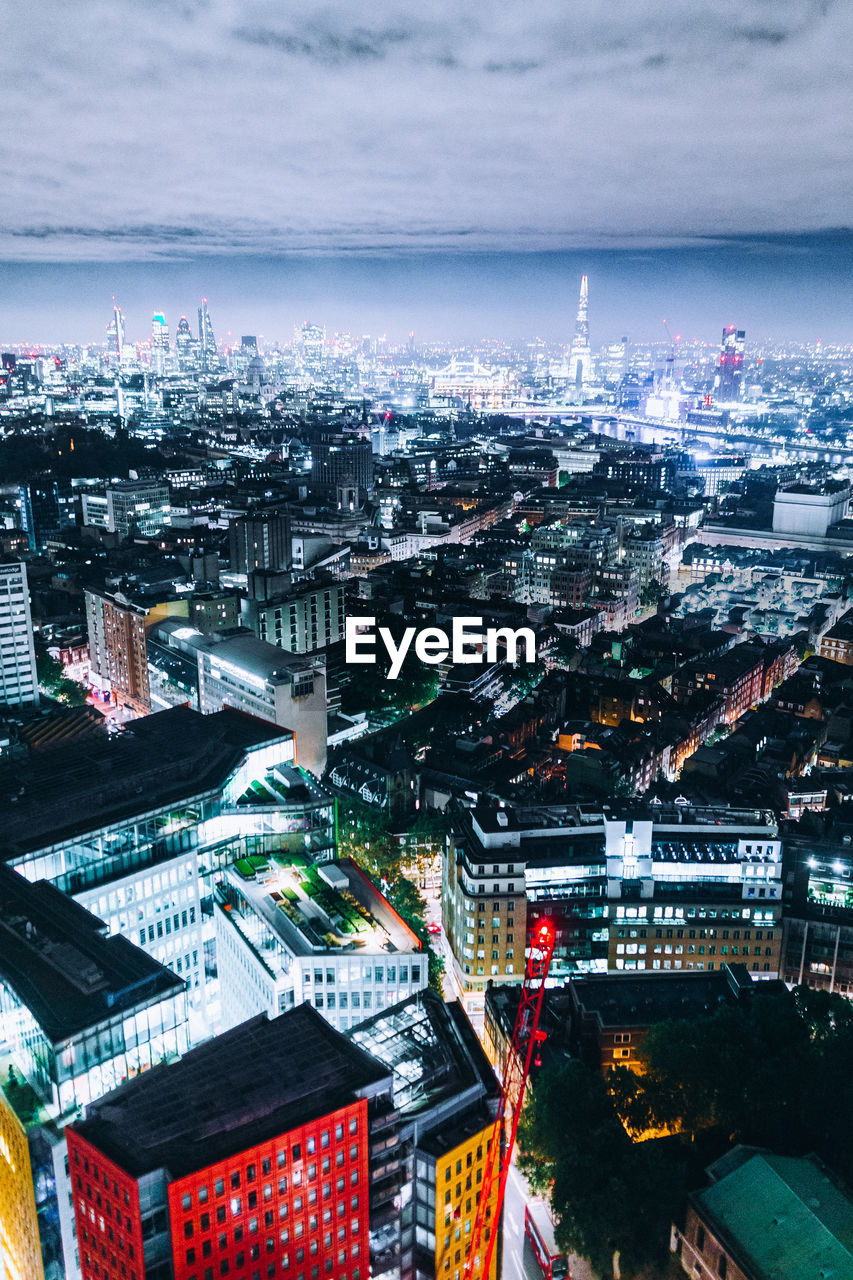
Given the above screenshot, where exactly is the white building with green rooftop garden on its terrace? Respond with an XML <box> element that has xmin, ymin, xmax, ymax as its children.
<box><xmin>215</xmin><ymin>855</ymin><xmax>429</xmax><ymax>1030</ymax></box>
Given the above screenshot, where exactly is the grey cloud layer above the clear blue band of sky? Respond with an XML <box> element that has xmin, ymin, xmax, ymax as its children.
<box><xmin>0</xmin><ymin>0</ymin><xmax>853</xmax><ymax>337</ymax></box>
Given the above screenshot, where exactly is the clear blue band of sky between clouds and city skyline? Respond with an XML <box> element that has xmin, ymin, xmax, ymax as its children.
<box><xmin>0</xmin><ymin>232</ymin><xmax>853</xmax><ymax>347</ymax></box>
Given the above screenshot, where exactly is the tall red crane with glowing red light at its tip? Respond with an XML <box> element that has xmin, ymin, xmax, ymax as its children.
<box><xmin>464</xmin><ymin>923</ymin><xmax>555</xmax><ymax>1280</ymax></box>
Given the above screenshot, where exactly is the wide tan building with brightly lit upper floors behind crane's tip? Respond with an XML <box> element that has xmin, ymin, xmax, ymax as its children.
<box><xmin>442</xmin><ymin>804</ymin><xmax>783</xmax><ymax>995</ymax></box>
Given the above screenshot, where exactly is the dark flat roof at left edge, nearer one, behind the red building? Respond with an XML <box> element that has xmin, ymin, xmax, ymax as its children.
<box><xmin>0</xmin><ymin>867</ymin><xmax>184</xmax><ymax>1044</ymax></box>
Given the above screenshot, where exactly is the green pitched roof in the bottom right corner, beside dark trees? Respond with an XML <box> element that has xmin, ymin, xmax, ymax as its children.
<box><xmin>692</xmin><ymin>1149</ymin><xmax>853</xmax><ymax>1280</ymax></box>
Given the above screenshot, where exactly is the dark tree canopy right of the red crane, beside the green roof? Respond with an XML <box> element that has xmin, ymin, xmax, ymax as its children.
<box><xmin>519</xmin><ymin>983</ymin><xmax>853</xmax><ymax>1280</ymax></box>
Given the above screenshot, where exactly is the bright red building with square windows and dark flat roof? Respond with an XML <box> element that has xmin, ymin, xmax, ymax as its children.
<box><xmin>68</xmin><ymin>1005</ymin><xmax>384</xmax><ymax>1280</ymax></box>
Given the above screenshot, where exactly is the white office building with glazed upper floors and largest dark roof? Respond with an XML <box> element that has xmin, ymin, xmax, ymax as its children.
<box><xmin>0</xmin><ymin>705</ymin><xmax>295</xmax><ymax>1038</ymax></box>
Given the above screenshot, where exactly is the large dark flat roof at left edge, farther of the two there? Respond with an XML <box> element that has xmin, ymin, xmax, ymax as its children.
<box><xmin>0</xmin><ymin>707</ymin><xmax>293</xmax><ymax>861</ymax></box>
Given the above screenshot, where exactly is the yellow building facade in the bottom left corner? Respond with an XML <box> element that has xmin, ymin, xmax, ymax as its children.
<box><xmin>0</xmin><ymin>1091</ymin><xmax>45</xmax><ymax>1280</ymax></box>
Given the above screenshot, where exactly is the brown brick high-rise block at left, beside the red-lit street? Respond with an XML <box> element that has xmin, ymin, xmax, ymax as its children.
<box><xmin>86</xmin><ymin>591</ymin><xmax>151</xmax><ymax>716</ymax></box>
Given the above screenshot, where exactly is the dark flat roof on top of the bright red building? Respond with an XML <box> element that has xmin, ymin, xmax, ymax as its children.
<box><xmin>73</xmin><ymin>1005</ymin><xmax>391</xmax><ymax>1178</ymax></box>
